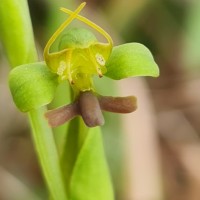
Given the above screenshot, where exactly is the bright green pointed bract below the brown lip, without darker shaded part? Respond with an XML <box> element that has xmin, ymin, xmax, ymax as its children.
<box><xmin>70</xmin><ymin>127</ymin><xmax>114</xmax><ymax>200</ymax></box>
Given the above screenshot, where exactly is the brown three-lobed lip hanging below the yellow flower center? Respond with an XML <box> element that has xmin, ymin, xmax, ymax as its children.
<box><xmin>45</xmin><ymin>91</ymin><xmax>137</xmax><ymax>127</ymax></box>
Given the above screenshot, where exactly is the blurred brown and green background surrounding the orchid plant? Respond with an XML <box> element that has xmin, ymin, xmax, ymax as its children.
<box><xmin>0</xmin><ymin>0</ymin><xmax>200</xmax><ymax>200</ymax></box>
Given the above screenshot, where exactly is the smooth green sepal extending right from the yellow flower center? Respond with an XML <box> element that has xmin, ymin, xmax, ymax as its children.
<box><xmin>105</xmin><ymin>43</ymin><xmax>159</xmax><ymax>80</ymax></box>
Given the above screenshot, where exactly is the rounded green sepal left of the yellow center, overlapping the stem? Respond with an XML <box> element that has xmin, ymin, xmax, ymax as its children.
<box><xmin>9</xmin><ymin>62</ymin><xmax>58</xmax><ymax>112</ymax></box>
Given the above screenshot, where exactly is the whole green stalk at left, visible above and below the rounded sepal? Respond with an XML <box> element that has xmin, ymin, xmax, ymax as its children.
<box><xmin>0</xmin><ymin>0</ymin><xmax>67</xmax><ymax>200</ymax></box>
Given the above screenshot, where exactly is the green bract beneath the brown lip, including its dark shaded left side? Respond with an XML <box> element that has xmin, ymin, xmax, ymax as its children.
<box><xmin>61</xmin><ymin>117</ymin><xmax>114</xmax><ymax>200</ymax></box>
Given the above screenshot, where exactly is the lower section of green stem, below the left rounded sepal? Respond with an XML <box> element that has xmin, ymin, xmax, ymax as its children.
<box><xmin>29</xmin><ymin>107</ymin><xmax>67</xmax><ymax>200</ymax></box>
